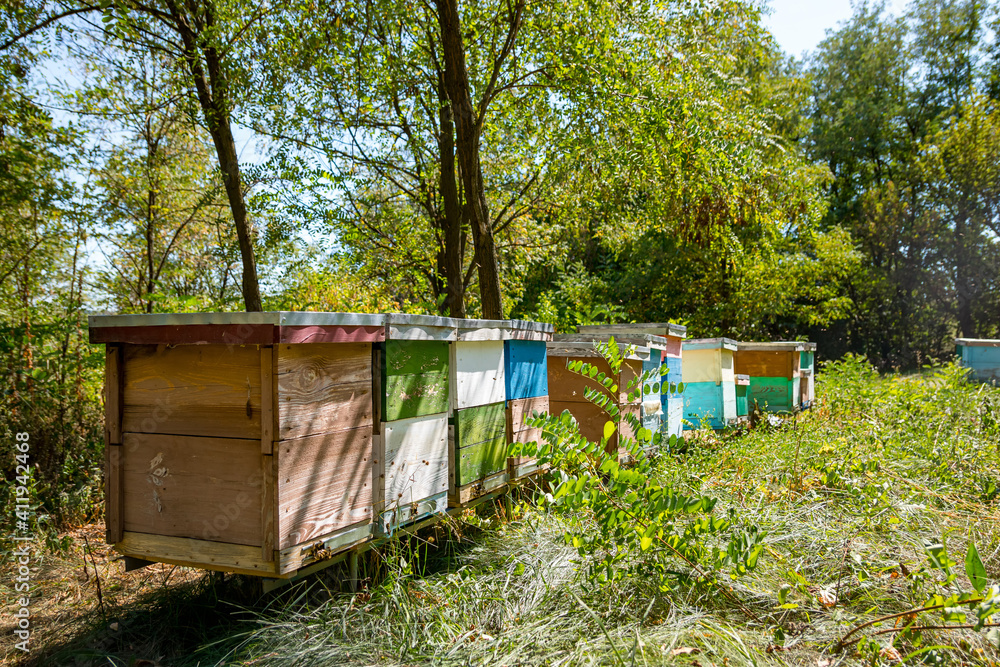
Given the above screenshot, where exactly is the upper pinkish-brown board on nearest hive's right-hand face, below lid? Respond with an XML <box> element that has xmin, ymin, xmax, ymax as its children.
<box><xmin>277</xmin><ymin>343</ymin><xmax>374</xmax><ymax>440</ymax></box>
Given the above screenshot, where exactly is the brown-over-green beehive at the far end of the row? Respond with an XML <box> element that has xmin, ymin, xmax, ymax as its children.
<box><xmin>736</xmin><ymin>341</ymin><xmax>805</xmax><ymax>413</ymax></box>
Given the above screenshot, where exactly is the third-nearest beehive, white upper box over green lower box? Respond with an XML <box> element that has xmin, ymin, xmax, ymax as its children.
<box><xmin>448</xmin><ymin>320</ymin><xmax>508</xmax><ymax>507</ymax></box>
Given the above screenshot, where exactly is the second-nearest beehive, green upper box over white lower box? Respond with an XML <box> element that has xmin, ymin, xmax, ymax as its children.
<box><xmin>373</xmin><ymin>314</ymin><xmax>458</xmax><ymax>535</ymax></box>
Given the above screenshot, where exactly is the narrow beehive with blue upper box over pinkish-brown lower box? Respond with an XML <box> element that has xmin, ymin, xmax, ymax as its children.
<box><xmin>504</xmin><ymin>320</ymin><xmax>553</xmax><ymax>479</ymax></box>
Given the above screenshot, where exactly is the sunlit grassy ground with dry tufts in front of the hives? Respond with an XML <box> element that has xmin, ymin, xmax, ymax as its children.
<box><xmin>0</xmin><ymin>359</ymin><xmax>1000</xmax><ymax>667</ymax></box>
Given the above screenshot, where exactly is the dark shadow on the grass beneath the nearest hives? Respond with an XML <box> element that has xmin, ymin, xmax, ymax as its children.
<box><xmin>22</xmin><ymin>508</ymin><xmax>500</xmax><ymax>667</ymax></box>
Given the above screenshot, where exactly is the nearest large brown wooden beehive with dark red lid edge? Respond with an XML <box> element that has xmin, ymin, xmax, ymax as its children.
<box><xmin>90</xmin><ymin>313</ymin><xmax>385</xmax><ymax>578</ymax></box>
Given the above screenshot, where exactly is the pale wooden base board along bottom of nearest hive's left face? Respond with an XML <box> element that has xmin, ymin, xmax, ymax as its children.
<box><xmin>115</xmin><ymin>531</ymin><xmax>277</xmax><ymax>576</ymax></box>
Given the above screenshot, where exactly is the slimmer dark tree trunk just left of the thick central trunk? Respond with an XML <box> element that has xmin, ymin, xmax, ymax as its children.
<box><xmin>438</xmin><ymin>81</ymin><xmax>465</xmax><ymax>317</ymax></box>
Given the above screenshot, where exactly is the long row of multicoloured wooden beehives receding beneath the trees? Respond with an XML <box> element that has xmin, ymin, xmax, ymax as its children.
<box><xmin>90</xmin><ymin>313</ymin><xmax>812</xmax><ymax>578</ymax></box>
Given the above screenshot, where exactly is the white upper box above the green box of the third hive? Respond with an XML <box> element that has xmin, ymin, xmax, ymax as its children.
<box><xmin>448</xmin><ymin>340</ymin><xmax>506</xmax><ymax>410</ymax></box>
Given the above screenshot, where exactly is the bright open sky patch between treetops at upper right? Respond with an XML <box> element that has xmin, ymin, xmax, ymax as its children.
<box><xmin>764</xmin><ymin>0</ymin><xmax>907</xmax><ymax>58</ymax></box>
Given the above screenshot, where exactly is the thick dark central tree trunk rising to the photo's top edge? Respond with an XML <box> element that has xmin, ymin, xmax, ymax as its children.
<box><xmin>436</xmin><ymin>0</ymin><xmax>503</xmax><ymax>320</ymax></box>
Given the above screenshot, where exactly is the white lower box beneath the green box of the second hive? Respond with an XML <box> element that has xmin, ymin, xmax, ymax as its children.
<box><xmin>376</xmin><ymin>414</ymin><xmax>448</xmax><ymax>512</ymax></box>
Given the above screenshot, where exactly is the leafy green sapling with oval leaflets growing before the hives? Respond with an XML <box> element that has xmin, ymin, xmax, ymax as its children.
<box><xmin>514</xmin><ymin>338</ymin><xmax>764</xmax><ymax>604</ymax></box>
